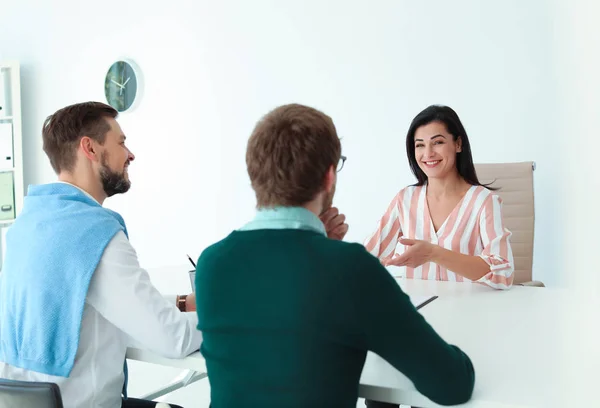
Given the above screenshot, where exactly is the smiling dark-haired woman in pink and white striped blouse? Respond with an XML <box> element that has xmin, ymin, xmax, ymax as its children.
<box><xmin>365</xmin><ymin>105</ymin><xmax>514</xmax><ymax>289</ymax></box>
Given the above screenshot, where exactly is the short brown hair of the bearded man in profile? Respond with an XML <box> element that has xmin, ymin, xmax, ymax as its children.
<box><xmin>42</xmin><ymin>102</ymin><xmax>118</xmax><ymax>174</ymax></box>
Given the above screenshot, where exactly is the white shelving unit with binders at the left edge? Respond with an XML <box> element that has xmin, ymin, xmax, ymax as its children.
<box><xmin>0</xmin><ymin>61</ymin><xmax>25</xmax><ymax>265</ymax></box>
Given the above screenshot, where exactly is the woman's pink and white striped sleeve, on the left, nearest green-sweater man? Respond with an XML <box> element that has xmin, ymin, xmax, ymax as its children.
<box><xmin>364</xmin><ymin>191</ymin><xmax>402</xmax><ymax>260</ymax></box>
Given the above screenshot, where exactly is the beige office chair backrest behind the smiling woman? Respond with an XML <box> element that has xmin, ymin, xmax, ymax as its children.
<box><xmin>475</xmin><ymin>162</ymin><xmax>544</xmax><ymax>286</ymax></box>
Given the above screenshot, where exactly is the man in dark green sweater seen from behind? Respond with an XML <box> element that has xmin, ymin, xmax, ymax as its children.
<box><xmin>196</xmin><ymin>105</ymin><xmax>474</xmax><ymax>408</ymax></box>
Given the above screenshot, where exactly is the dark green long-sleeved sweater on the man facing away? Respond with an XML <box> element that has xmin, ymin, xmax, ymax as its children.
<box><xmin>196</xmin><ymin>229</ymin><xmax>474</xmax><ymax>408</ymax></box>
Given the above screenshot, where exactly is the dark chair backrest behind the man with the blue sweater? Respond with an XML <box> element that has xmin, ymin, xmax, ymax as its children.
<box><xmin>0</xmin><ymin>379</ymin><xmax>63</xmax><ymax>408</ymax></box>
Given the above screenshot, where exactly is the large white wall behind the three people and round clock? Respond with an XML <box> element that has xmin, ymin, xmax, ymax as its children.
<box><xmin>0</xmin><ymin>0</ymin><xmax>563</xmax><ymax>285</ymax></box>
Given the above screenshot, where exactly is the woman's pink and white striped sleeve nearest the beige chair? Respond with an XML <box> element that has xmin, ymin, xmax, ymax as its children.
<box><xmin>477</xmin><ymin>194</ymin><xmax>515</xmax><ymax>289</ymax></box>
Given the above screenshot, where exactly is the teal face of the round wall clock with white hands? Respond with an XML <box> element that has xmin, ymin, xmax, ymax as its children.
<box><xmin>104</xmin><ymin>61</ymin><xmax>138</xmax><ymax>112</ymax></box>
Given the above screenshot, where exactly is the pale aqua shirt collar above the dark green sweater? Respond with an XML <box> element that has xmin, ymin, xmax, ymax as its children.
<box><xmin>240</xmin><ymin>207</ymin><xmax>327</xmax><ymax>236</ymax></box>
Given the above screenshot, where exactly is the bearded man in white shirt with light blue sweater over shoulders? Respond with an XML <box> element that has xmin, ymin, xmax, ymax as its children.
<box><xmin>0</xmin><ymin>102</ymin><xmax>202</xmax><ymax>408</ymax></box>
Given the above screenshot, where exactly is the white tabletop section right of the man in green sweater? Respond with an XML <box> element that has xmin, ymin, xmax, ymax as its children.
<box><xmin>359</xmin><ymin>280</ymin><xmax>600</xmax><ymax>408</ymax></box>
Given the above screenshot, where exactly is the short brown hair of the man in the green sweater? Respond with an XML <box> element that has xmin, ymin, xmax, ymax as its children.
<box><xmin>246</xmin><ymin>104</ymin><xmax>342</xmax><ymax>207</ymax></box>
